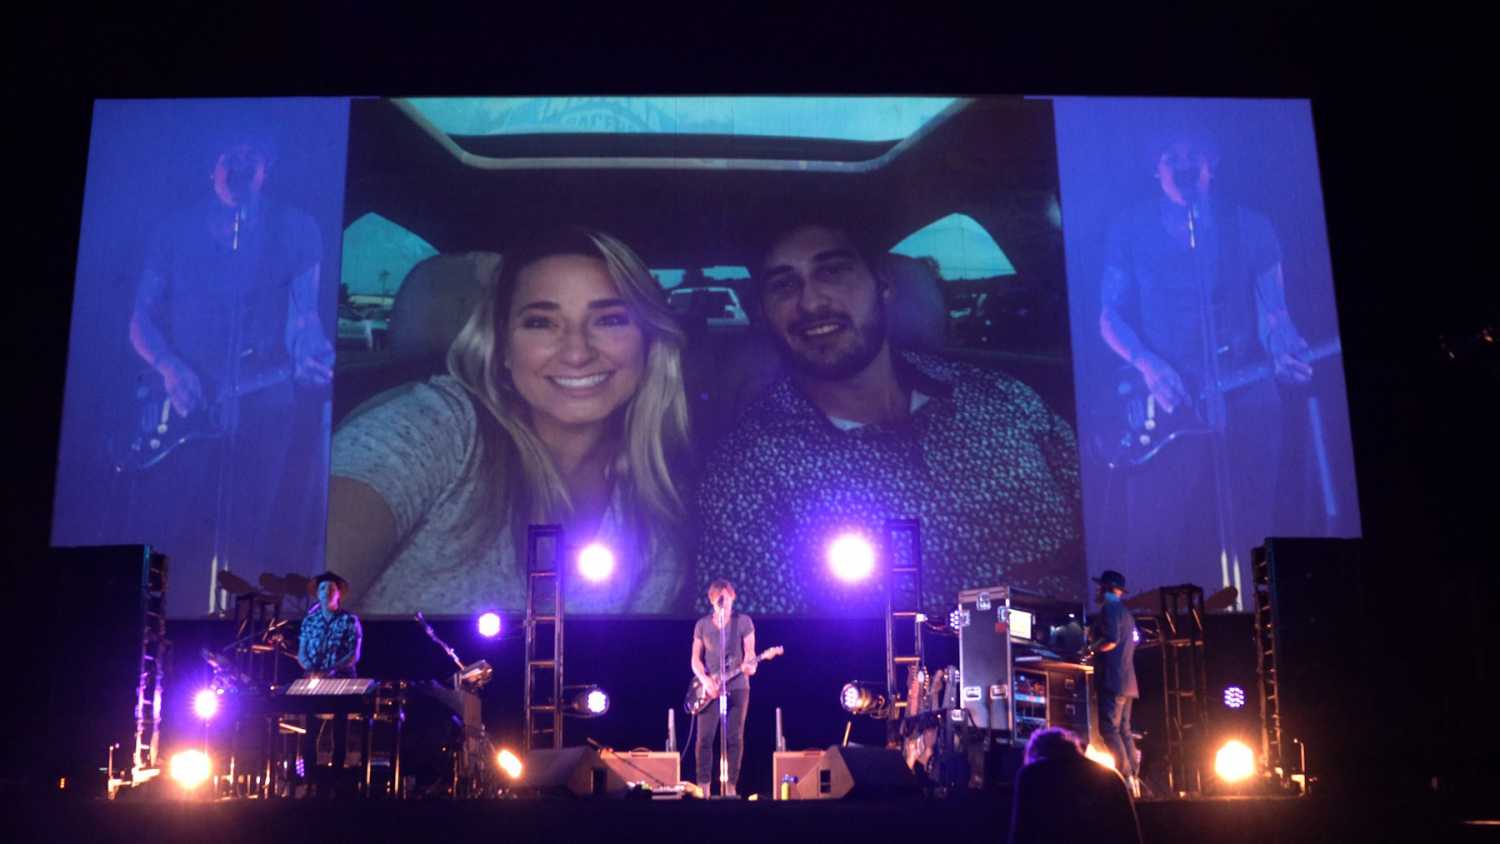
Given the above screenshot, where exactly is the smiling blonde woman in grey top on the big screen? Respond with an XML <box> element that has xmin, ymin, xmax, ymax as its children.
<box><xmin>329</xmin><ymin>226</ymin><xmax>690</xmax><ymax>615</ymax></box>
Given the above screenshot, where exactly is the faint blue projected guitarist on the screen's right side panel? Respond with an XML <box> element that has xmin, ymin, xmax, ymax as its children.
<box><xmin>1100</xmin><ymin>130</ymin><xmax>1313</xmax><ymax>586</ymax></box>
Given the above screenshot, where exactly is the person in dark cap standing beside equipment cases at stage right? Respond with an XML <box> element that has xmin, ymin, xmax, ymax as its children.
<box><xmin>1089</xmin><ymin>570</ymin><xmax>1140</xmax><ymax>792</ymax></box>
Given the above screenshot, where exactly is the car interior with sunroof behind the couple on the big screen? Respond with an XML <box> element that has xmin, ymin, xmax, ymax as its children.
<box><xmin>333</xmin><ymin>97</ymin><xmax>1073</xmax><ymax>444</ymax></box>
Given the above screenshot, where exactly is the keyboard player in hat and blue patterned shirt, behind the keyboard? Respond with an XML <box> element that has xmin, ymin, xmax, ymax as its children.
<box><xmin>297</xmin><ymin>571</ymin><xmax>365</xmax><ymax>790</ymax></box>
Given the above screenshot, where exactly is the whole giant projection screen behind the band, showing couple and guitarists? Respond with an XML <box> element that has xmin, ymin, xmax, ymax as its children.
<box><xmin>53</xmin><ymin>96</ymin><xmax>1358</xmax><ymax>618</ymax></box>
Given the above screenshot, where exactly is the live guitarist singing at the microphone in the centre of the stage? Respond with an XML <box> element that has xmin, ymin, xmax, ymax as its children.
<box><xmin>692</xmin><ymin>579</ymin><xmax>756</xmax><ymax>798</ymax></box>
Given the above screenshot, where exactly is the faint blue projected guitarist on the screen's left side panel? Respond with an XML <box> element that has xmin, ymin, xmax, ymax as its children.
<box><xmin>126</xmin><ymin>132</ymin><xmax>333</xmax><ymax>609</ymax></box>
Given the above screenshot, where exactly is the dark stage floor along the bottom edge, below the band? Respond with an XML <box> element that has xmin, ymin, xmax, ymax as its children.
<box><xmin>5</xmin><ymin>795</ymin><xmax>1500</xmax><ymax>844</ymax></box>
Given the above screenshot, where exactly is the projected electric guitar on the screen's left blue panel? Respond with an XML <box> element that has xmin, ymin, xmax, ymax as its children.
<box><xmin>113</xmin><ymin>366</ymin><xmax>293</xmax><ymax>472</ymax></box>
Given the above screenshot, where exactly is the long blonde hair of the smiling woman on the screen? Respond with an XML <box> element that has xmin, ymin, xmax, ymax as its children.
<box><xmin>449</xmin><ymin>226</ymin><xmax>689</xmax><ymax>551</ymax></box>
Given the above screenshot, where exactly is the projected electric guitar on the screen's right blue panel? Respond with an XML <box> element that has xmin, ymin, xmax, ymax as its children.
<box><xmin>1095</xmin><ymin>339</ymin><xmax>1341</xmax><ymax>469</ymax></box>
